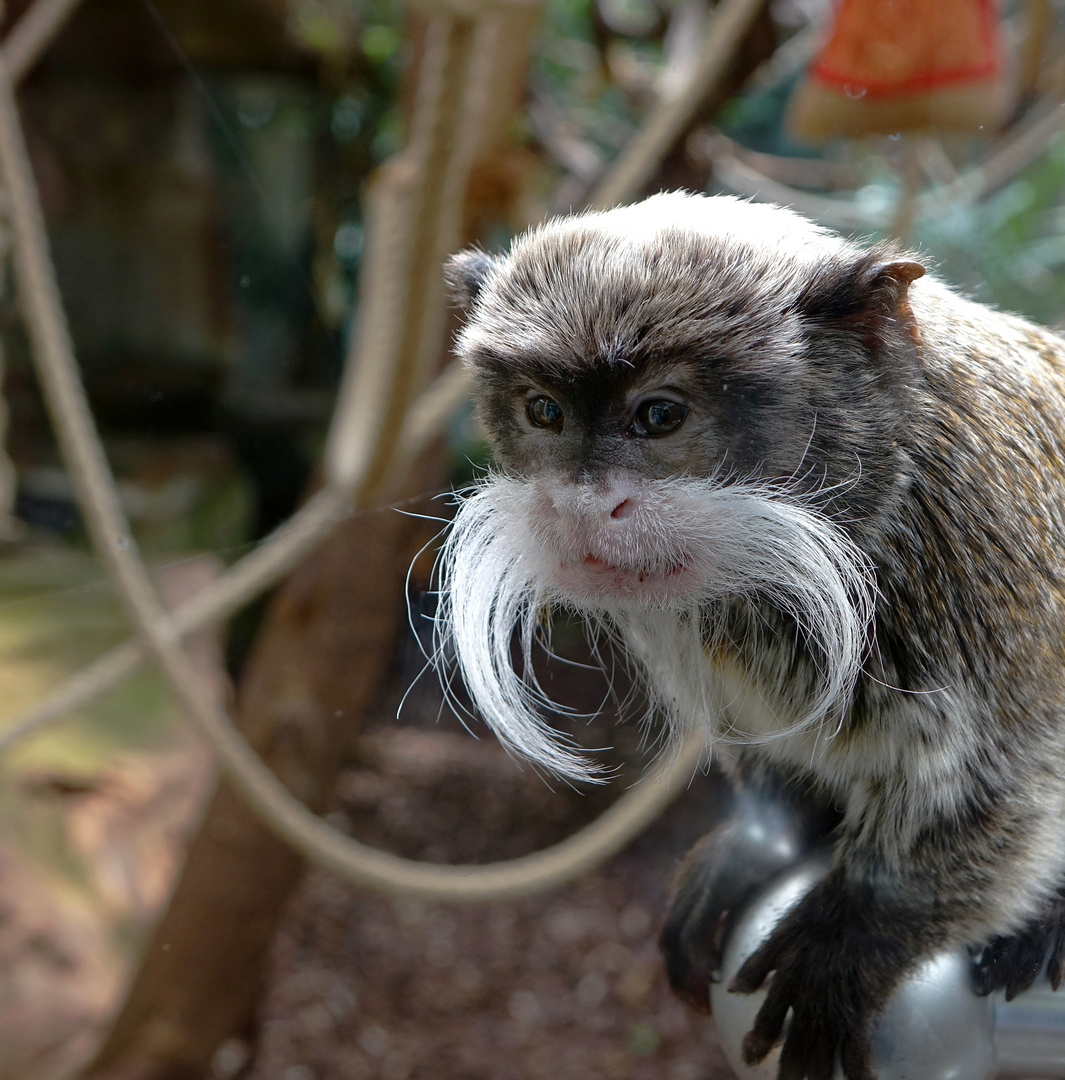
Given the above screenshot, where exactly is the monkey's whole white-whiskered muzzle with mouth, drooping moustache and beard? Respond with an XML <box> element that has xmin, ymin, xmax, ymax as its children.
<box><xmin>434</xmin><ymin>476</ymin><xmax>874</xmax><ymax>780</ymax></box>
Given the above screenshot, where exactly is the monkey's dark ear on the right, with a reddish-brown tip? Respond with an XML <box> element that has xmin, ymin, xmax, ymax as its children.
<box><xmin>799</xmin><ymin>247</ymin><xmax>925</xmax><ymax>321</ymax></box>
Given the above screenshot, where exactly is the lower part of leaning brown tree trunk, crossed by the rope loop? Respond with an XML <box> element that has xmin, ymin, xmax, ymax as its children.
<box><xmin>84</xmin><ymin>511</ymin><xmax>418</xmax><ymax>1080</ymax></box>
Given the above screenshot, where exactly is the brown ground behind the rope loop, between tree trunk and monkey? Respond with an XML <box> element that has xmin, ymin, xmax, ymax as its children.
<box><xmin>233</xmin><ymin>725</ymin><xmax>731</xmax><ymax>1080</ymax></box>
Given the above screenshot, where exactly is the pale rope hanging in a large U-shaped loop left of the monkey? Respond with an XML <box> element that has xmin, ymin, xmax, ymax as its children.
<box><xmin>0</xmin><ymin>23</ymin><xmax>702</xmax><ymax>901</ymax></box>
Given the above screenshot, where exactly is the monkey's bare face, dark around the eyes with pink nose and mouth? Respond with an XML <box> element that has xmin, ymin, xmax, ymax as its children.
<box><xmin>473</xmin><ymin>364</ymin><xmax>730</xmax><ymax>607</ymax></box>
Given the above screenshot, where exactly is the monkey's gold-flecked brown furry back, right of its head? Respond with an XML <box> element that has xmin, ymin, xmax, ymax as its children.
<box><xmin>846</xmin><ymin>280</ymin><xmax>1065</xmax><ymax>760</ymax></box>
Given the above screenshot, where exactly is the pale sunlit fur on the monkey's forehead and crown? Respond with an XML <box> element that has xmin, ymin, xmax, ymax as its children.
<box><xmin>448</xmin><ymin>192</ymin><xmax>863</xmax><ymax>365</ymax></box>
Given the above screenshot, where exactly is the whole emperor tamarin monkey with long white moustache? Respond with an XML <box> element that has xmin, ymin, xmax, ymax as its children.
<box><xmin>441</xmin><ymin>193</ymin><xmax>1065</xmax><ymax>1080</ymax></box>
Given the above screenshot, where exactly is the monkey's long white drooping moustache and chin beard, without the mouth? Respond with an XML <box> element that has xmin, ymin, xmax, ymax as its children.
<box><xmin>434</xmin><ymin>476</ymin><xmax>875</xmax><ymax>780</ymax></box>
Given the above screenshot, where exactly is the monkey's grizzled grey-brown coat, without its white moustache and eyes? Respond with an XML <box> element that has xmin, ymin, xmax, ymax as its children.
<box><xmin>448</xmin><ymin>195</ymin><xmax>1065</xmax><ymax>1080</ymax></box>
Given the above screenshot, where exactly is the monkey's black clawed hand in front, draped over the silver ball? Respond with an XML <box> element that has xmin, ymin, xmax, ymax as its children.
<box><xmin>729</xmin><ymin>874</ymin><xmax>926</xmax><ymax>1080</ymax></box>
